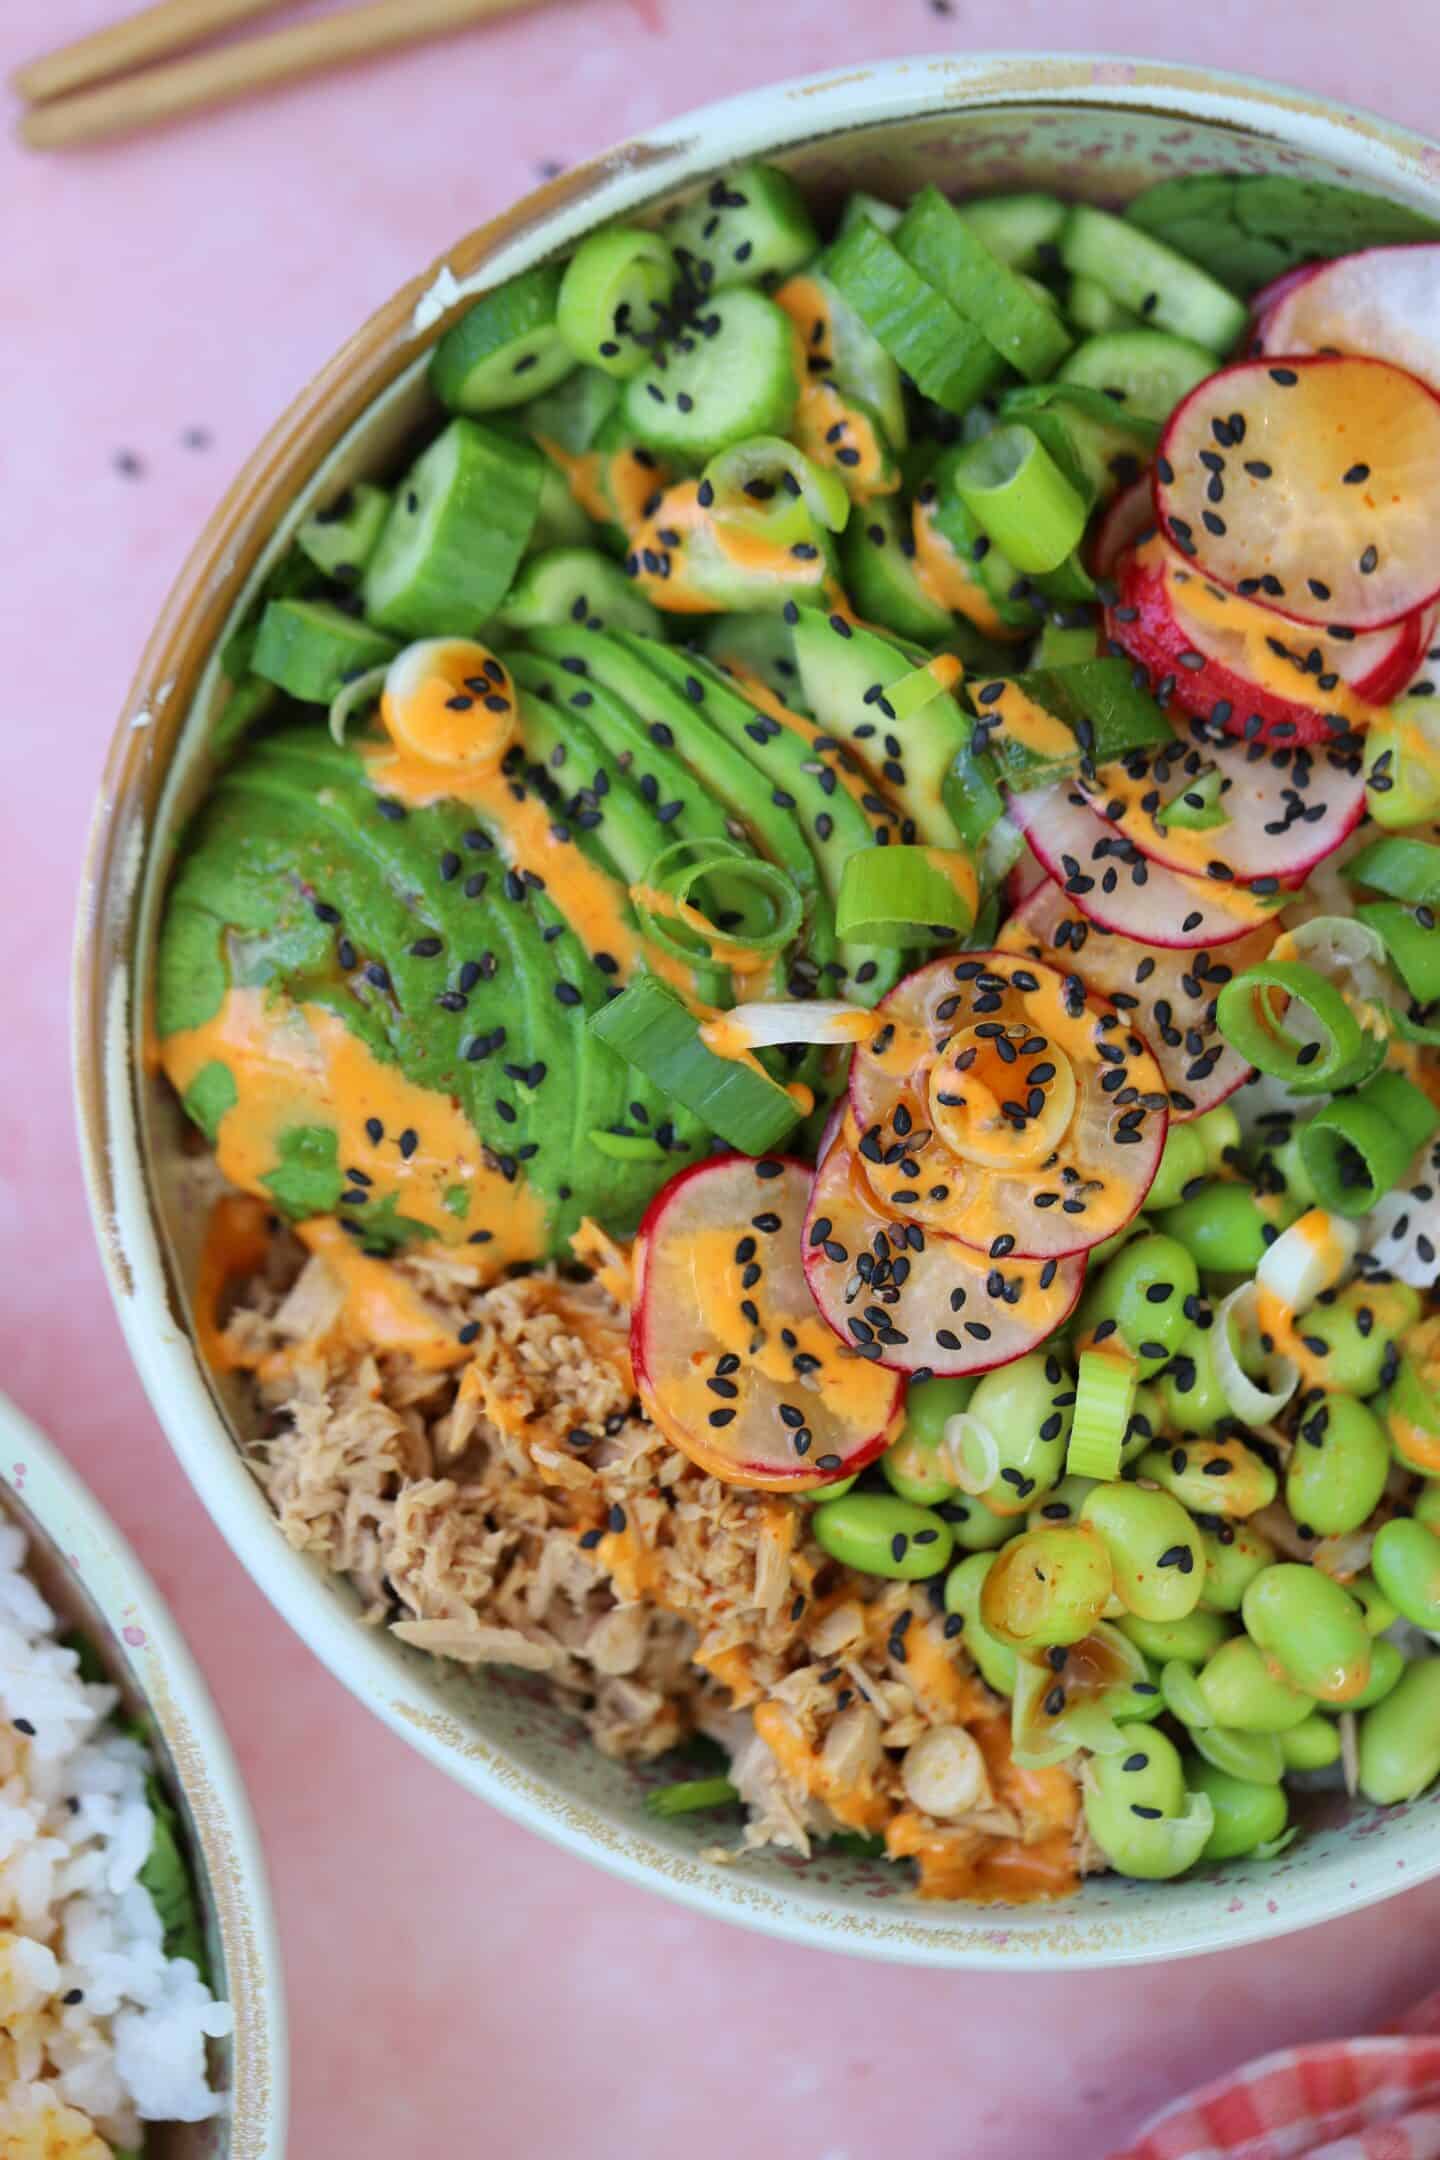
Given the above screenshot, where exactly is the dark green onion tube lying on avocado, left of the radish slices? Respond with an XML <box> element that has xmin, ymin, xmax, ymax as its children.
<box><xmin>589</xmin><ymin>974</ymin><xmax>801</xmax><ymax>1156</ymax></box>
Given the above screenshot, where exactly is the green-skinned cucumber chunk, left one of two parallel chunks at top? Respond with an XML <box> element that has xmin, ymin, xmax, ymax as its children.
<box><xmin>820</xmin><ymin>218</ymin><xmax>1004</xmax><ymax>413</ymax></box>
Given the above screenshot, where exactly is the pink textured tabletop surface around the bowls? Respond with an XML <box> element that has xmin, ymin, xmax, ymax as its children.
<box><xmin>0</xmin><ymin>0</ymin><xmax>1440</xmax><ymax>2160</ymax></box>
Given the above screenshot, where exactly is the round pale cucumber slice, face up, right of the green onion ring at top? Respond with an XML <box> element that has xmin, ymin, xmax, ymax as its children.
<box><xmin>620</xmin><ymin>289</ymin><xmax>799</xmax><ymax>460</ymax></box>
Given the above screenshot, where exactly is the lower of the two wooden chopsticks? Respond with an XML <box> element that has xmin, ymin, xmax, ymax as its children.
<box><xmin>17</xmin><ymin>0</ymin><xmax>569</xmax><ymax>149</ymax></box>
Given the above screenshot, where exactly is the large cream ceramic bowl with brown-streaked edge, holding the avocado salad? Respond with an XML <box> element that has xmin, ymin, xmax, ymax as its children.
<box><xmin>76</xmin><ymin>56</ymin><xmax>1440</xmax><ymax>1968</ymax></box>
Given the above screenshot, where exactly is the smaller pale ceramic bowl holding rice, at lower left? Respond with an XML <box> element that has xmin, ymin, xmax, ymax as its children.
<box><xmin>0</xmin><ymin>1395</ymin><xmax>287</xmax><ymax>2160</ymax></box>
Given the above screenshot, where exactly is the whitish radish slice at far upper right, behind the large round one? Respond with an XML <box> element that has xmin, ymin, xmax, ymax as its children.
<box><xmin>1256</xmin><ymin>240</ymin><xmax>1440</xmax><ymax>403</ymax></box>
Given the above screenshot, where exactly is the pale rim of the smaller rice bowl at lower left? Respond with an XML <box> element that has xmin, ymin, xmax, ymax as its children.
<box><xmin>0</xmin><ymin>1395</ymin><xmax>289</xmax><ymax>2160</ymax></box>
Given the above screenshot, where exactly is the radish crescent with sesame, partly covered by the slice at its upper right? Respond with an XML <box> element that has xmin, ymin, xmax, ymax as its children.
<box><xmin>1010</xmin><ymin>780</ymin><xmax>1269</xmax><ymax>948</ymax></box>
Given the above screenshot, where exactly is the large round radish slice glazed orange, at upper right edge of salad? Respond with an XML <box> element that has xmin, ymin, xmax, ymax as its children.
<box><xmin>1155</xmin><ymin>354</ymin><xmax>1440</xmax><ymax>631</ymax></box>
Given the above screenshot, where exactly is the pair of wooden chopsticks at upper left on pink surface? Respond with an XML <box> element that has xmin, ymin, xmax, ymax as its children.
<box><xmin>11</xmin><ymin>0</ymin><xmax>561</xmax><ymax>149</ymax></box>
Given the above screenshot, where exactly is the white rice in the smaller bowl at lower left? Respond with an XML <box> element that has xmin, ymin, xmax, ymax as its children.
<box><xmin>0</xmin><ymin>1521</ymin><xmax>233</xmax><ymax>2160</ymax></box>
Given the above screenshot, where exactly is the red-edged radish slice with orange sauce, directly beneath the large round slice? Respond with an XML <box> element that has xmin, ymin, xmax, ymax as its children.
<box><xmin>1105</xmin><ymin>536</ymin><xmax>1434</xmax><ymax>747</ymax></box>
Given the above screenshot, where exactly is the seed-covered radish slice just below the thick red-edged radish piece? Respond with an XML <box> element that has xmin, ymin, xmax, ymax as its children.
<box><xmin>1075</xmin><ymin>721</ymin><xmax>1364</xmax><ymax>890</ymax></box>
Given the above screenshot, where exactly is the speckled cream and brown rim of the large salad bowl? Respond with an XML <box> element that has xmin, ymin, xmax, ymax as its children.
<box><xmin>73</xmin><ymin>54</ymin><xmax>1440</xmax><ymax>1970</ymax></box>
